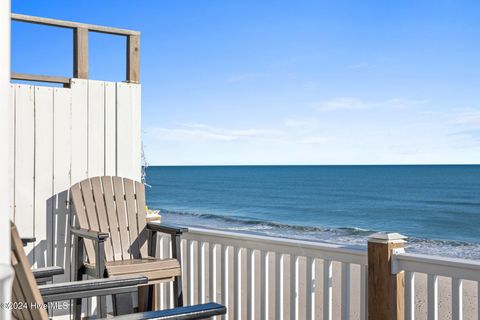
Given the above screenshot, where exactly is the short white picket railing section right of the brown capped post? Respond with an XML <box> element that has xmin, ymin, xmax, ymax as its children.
<box><xmin>392</xmin><ymin>253</ymin><xmax>480</xmax><ymax>320</ymax></box>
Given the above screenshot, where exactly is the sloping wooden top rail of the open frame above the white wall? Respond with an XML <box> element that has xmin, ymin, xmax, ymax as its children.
<box><xmin>11</xmin><ymin>13</ymin><xmax>140</xmax><ymax>36</ymax></box>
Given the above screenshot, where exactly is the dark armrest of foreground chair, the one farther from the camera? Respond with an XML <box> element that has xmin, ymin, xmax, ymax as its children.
<box><xmin>38</xmin><ymin>276</ymin><xmax>148</xmax><ymax>302</ymax></box>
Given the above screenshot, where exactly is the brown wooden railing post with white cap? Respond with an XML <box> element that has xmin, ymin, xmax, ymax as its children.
<box><xmin>368</xmin><ymin>233</ymin><xmax>406</xmax><ymax>320</ymax></box>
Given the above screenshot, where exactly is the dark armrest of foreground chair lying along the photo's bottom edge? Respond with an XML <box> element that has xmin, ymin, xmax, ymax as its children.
<box><xmin>101</xmin><ymin>302</ymin><xmax>227</xmax><ymax>320</ymax></box>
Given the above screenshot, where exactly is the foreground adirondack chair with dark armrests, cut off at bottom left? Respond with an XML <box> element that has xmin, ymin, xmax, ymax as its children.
<box><xmin>10</xmin><ymin>223</ymin><xmax>226</xmax><ymax>320</ymax></box>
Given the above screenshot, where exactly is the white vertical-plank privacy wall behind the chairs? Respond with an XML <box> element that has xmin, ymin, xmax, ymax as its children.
<box><xmin>10</xmin><ymin>79</ymin><xmax>141</xmax><ymax>272</ymax></box>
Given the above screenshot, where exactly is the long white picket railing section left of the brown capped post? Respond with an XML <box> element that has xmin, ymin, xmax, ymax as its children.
<box><xmin>158</xmin><ymin>228</ymin><xmax>367</xmax><ymax>320</ymax></box>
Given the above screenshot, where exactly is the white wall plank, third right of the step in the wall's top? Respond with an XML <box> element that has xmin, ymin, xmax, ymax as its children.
<box><xmin>105</xmin><ymin>82</ymin><xmax>117</xmax><ymax>176</ymax></box>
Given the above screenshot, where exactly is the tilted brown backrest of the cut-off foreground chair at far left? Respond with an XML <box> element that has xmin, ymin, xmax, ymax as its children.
<box><xmin>10</xmin><ymin>223</ymin><xmax>48</xmax><ymax>320</ymax></box>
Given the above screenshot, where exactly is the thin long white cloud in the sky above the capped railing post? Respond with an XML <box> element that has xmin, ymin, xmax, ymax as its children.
<box><xmin>314</xmin><ymin>97</ymin><xmax>428</xmax><ymax>111</ymax></box>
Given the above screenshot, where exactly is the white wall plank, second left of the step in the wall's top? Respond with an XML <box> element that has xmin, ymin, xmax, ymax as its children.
<box><xmin>34</xmin><ymin>86</ymin><xmax>53</xmax><ymax>268</ymax></box>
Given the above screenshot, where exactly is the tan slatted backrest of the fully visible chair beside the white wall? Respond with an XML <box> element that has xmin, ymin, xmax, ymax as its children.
<box><xmin>71</xmin><ymin>176</ymin><xmax>148</xmax><ymax>262</ymax></box>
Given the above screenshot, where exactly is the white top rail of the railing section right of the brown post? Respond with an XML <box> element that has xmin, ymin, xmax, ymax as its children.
<box><xmin>392</xmin><ymin>253</ymin><xmax>480</xmax><ymax>281</ymax></box>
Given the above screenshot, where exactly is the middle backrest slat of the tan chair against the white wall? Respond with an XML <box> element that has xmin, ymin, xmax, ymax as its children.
<box><xmin>102</xmin><ymin>177</ymin><xmax>123</xmax><ymax>261</ymax></box>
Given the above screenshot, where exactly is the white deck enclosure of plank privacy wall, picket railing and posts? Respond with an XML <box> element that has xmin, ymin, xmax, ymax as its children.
<box><xmin>3</xmin><ymin>11</ymin><xmax>480</xmax><ymax>320</ymax></box>
